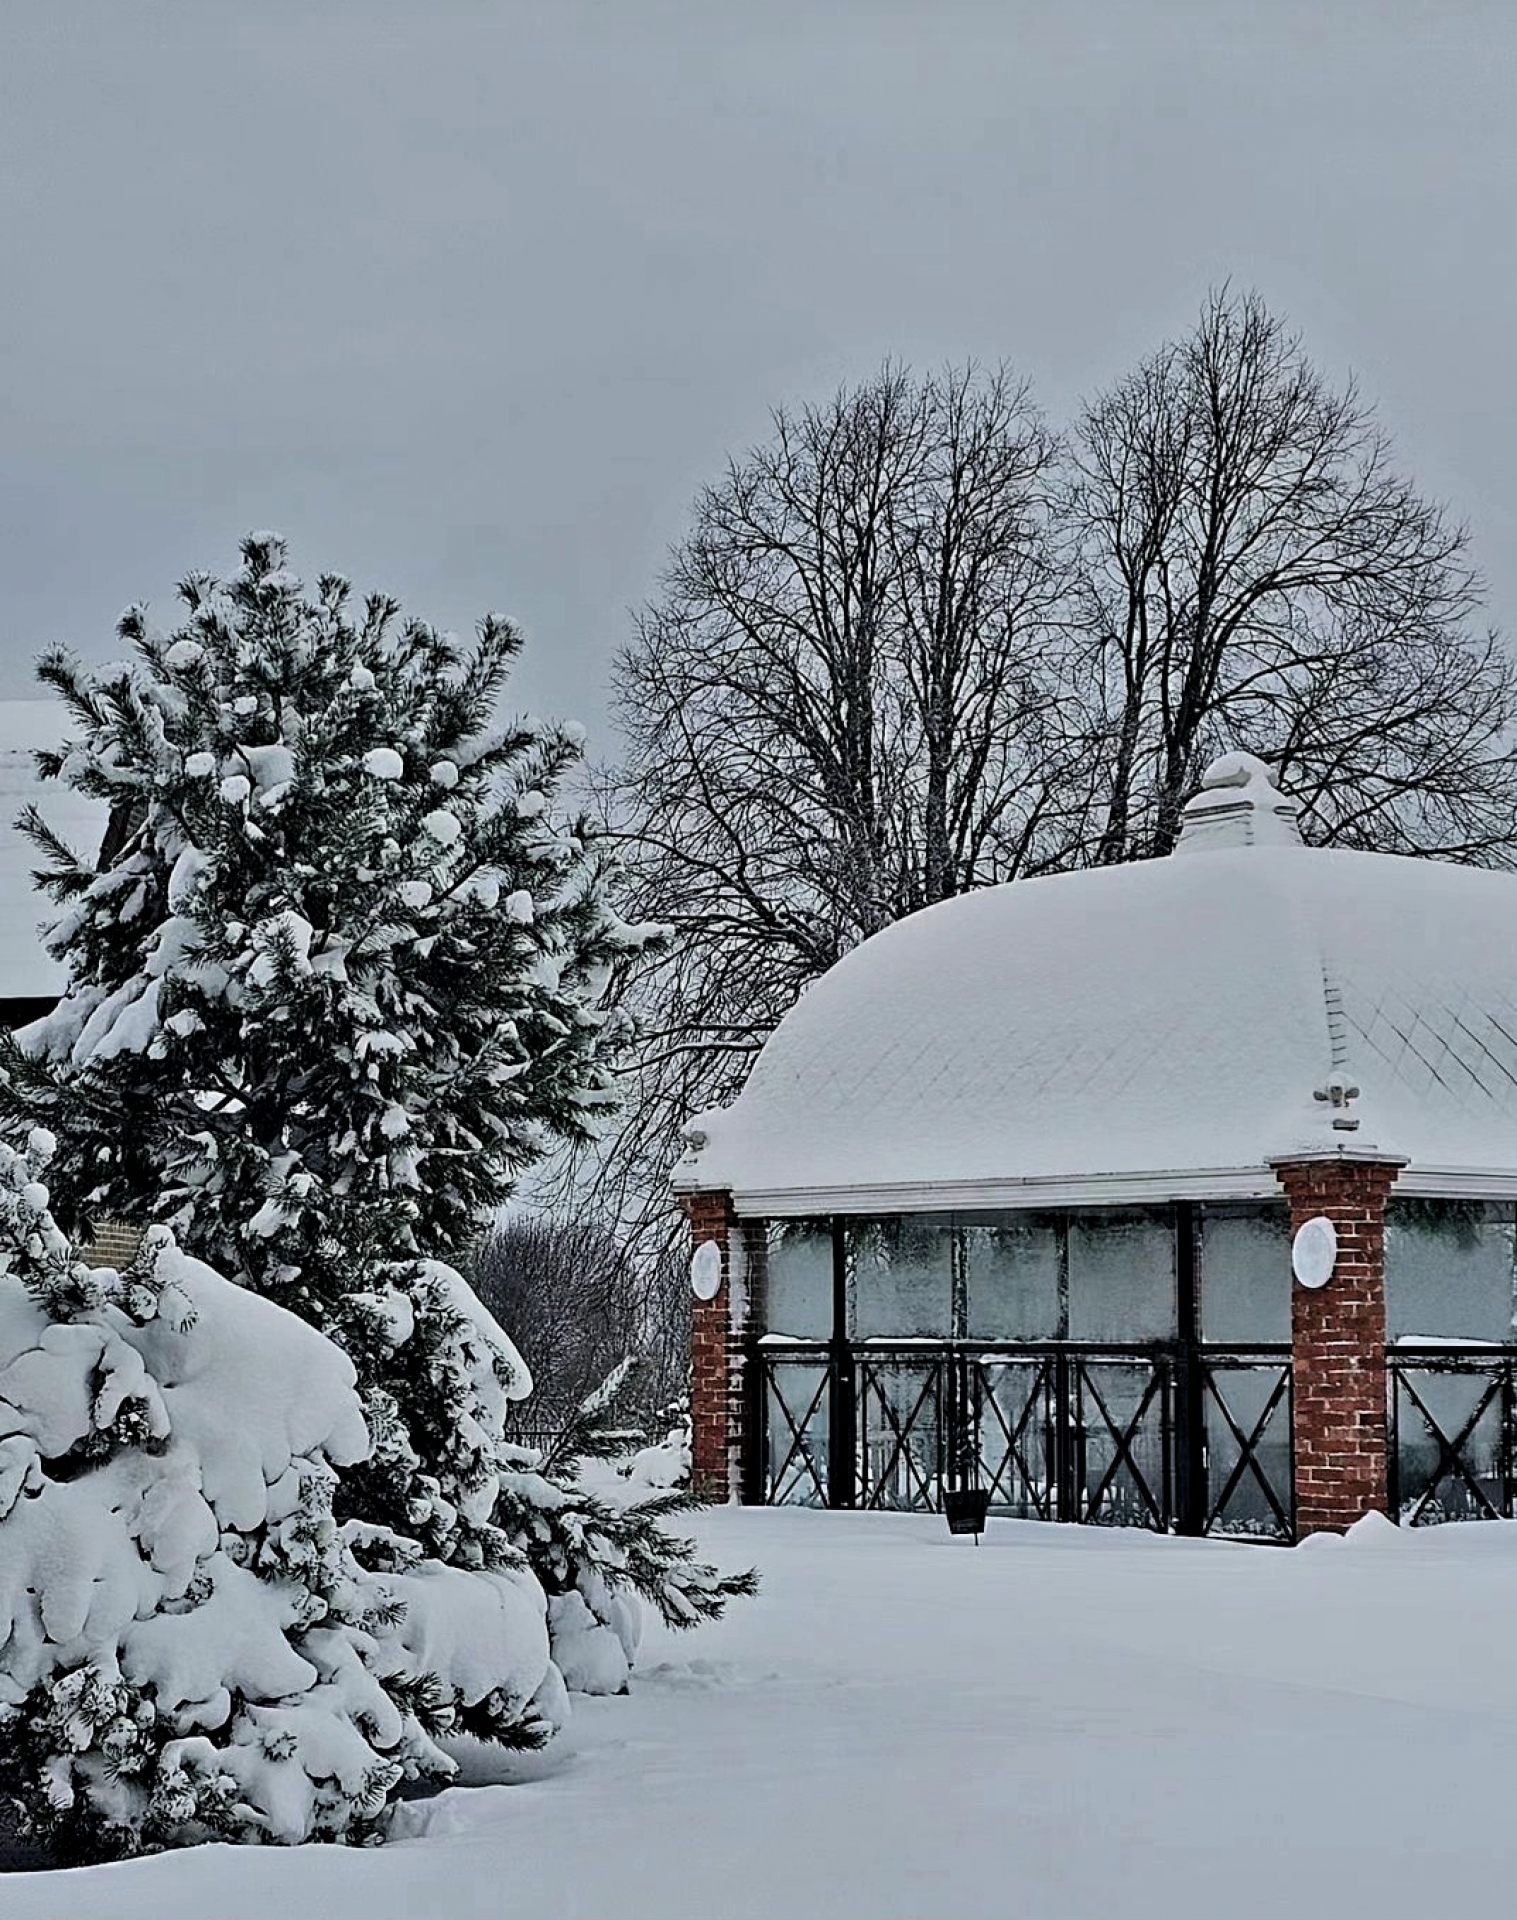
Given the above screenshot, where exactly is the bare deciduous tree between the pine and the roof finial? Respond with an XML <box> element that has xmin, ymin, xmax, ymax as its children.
<box><xmin>579</xmin><ymin>367</ymin><xmax>1081</xmax><ymax>1244</ymax></box>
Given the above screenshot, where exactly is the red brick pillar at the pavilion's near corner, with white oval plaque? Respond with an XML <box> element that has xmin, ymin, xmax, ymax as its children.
<box><xmin>1271</xmin><ymin>1152</ymin><xmax>1406</xmax><ymax>1540</ymax></box>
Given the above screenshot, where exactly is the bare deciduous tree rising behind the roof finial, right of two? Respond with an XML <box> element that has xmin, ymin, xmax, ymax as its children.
<box><xmin>1060</xmin><ymin>290</ymin><xmax>1517</xmax><ymax>862</ymax></box>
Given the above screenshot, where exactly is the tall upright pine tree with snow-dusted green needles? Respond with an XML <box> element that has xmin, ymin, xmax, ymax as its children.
<box><xmin>0</xmin><ymin>536</ymin><xmax>752</xmax><ymax>1712</ymax></box>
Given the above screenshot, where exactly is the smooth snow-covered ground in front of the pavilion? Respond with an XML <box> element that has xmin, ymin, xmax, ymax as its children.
<box><xmin>11</xmin><ymin>1509</ymin><xmax>1517</xmax><ymax>1920</ymax></box>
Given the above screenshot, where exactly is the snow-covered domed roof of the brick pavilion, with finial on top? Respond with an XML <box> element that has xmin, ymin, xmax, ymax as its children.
<box><xmin>676</xmin><ymin>753</ymin><xmax>1517</xmax><ymax>1213</ymax></box>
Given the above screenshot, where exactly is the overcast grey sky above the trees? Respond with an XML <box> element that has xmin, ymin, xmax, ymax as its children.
<box><xmin>0</xmin><ymin>0</ymin><xmax>1517</xmax><ymax>751</ymax></box>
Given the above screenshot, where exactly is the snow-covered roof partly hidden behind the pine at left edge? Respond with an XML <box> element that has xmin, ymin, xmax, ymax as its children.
<box><xmin>0</xmin><ymin>701</ymin><xmax>106</xmax><ymax>1000</ymax></box>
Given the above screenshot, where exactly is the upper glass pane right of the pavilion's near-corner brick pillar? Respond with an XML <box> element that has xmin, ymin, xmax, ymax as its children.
<box><xmin>1385</xmin><ymin>1200</ymin><xmax>1513</xmax><ymax>1340</ymax></box>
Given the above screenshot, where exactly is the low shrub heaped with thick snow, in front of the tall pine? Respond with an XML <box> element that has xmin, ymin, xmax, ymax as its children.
<box><xmin>0</xmin><ymin>1131</ymin><xmax>561</xmax><ymax>1859</ymax></box>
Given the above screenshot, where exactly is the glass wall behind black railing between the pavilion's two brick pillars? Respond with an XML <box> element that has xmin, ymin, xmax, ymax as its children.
<box><xmin>747</xmin><ymin>1202</ymin><xmax>1290</xmax><ymax>1538</ymax></box>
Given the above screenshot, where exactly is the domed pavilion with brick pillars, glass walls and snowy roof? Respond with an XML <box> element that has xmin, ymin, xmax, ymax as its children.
<box><xmin>676</xmin><ymin>753</ymin><xmax>1517</xmax><ymax>1540</ymax></box>
